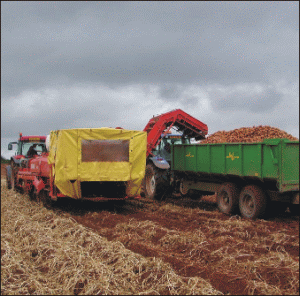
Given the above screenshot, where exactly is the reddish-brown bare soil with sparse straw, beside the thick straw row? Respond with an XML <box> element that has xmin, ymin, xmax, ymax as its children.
<box><xmin>1</xmin><ymin>165</ymin><xmax>299</xmax><ymax>295</ymax></box>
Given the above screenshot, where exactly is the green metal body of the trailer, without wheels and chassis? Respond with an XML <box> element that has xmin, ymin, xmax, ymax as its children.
<box><xmin>171</xmin><ymin>139</ymin><xmax>299</xmax><ymax>192</ymax></box>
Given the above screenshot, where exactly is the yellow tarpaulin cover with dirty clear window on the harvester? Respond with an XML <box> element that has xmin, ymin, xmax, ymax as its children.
<box><xmin>48</xmin><ymin>128</ymin><xmax>147</xmax><ymax>199</ymax></box>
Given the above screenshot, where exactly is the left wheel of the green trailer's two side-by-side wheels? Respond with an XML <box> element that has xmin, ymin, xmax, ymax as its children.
<box><xmin>217</xmin><ymin>183</ymin><xmax>240</xmax><ymax>215</ymax></box>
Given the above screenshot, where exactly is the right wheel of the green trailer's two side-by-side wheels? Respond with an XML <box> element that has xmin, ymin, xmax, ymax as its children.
<box><xmin>239</xmin><ymin>185</ymin><xmax>267</xmax><ymax>219</ymax></box>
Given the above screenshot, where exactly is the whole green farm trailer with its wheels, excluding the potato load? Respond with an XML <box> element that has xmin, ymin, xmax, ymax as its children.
<box><xmin>171</xmin><ymin>139</ymin><xmax>299</xmax><ymax>219</ymax></box>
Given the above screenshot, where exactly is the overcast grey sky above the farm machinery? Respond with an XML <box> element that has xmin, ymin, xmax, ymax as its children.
<box><xmin>1</xmin><ymin>1</ymin><xmax>299</xmax><ymax>157</ymax></box>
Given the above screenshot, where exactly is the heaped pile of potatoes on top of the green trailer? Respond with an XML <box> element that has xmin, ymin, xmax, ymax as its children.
<box><xmin>200</xmin><ymin>125</ymin><xmax>299</xmax><ymax>144</ymax></box>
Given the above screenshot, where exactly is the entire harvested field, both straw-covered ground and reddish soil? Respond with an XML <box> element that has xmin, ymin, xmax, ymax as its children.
<box><xmin>1</xmin><ymin>166</ymin><xmax>299</xmax><ymax>295</ymax></box>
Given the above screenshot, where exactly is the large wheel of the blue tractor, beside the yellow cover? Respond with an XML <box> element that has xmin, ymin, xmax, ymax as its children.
<box><xmin>144</xmin><ymin>163</ymin><xmax>170</xmax><ymax>200</ymax></box>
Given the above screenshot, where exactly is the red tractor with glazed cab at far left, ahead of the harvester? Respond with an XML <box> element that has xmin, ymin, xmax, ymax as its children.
<box><xmin>6</xmin><ymin>133</ymin><xmax>47</xmax><ymax>189</ymax></box>
